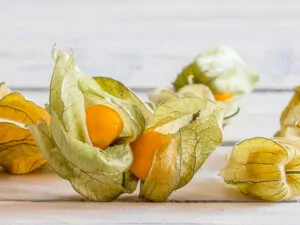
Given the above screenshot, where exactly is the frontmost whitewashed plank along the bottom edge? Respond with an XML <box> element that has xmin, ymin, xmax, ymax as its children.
<box><xmin>0</xmin><ymin>202</ymin><xmax>300</xmax><ymax>225</ymax></box>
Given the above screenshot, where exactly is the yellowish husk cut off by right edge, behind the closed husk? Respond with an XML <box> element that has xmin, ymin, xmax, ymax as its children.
<box><xmin>275</xmin><ymin>87</ymin><xmax>300</xmax><ymax>141</ymax></box>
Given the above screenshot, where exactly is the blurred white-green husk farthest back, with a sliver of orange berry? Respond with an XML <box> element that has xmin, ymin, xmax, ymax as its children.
<box><xmin>173</xmin><ymin>46</ymin><xmax>259</xmax><ymax>122</ymax></box>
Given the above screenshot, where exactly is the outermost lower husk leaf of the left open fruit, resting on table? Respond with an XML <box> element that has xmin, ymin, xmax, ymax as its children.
<box><xmin>30</xmin><ymin>121</ymin><xmax>138</xmax><ymax>201</ymax></box>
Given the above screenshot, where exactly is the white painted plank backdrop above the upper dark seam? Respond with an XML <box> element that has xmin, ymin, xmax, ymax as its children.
<box><xmin>0</xmin><ymin>0</ymin><xmax>300</xmax><ymax>88</ymax></box>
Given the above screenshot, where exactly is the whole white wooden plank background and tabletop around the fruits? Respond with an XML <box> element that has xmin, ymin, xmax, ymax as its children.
<box><xmin>0</xmin><ymin>0</ymin><xmax>300</xmax><ymax>224</ymax></box>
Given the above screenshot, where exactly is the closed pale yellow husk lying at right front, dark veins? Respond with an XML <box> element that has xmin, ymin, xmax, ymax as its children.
<box><xmin>221</xmin><ymin>137</ymin><xmax>300</xmax><ymax>201</ymax></box>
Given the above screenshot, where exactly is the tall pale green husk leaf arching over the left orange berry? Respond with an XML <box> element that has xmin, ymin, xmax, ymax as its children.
<box><xmin>50</xmin><ymin>52</ymin><xmax>145</xmax><ymax>144</ymax></box>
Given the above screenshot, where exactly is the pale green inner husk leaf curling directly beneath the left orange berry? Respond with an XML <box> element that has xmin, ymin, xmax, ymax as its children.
<box><xmin>50</xmin><ymin>106</ymin><xmax>132</xmax><ymax>174</ymax></box>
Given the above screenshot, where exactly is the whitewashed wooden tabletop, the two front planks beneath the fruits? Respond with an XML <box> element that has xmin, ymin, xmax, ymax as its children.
<box><xmin>0</xmin><ymin>147</ymin><xmax>300</xmax><ymax>225</ymax></box>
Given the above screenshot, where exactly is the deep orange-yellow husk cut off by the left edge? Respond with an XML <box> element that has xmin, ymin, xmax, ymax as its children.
<box><xmin>0</xmin><ymin>83</ymin><xmax>50</xmax><ymax>174</ymax></box>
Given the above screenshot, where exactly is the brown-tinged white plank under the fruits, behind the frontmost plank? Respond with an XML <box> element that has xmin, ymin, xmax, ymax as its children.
<box><xmin>0</xmin><ymin>147</ymin><xmax>297</xmax><ymax>203</ymax></box>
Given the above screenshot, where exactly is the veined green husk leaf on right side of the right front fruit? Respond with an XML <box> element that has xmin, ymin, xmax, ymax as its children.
<box><xmin>176</xmin><ymin>104</ymin><xmax>223</xmax><ymax>189</ymax></box>
